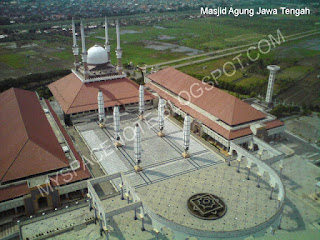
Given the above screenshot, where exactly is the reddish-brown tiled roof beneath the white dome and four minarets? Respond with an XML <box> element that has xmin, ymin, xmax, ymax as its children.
<box><xmin>49</xmin><ymin>73</ymin><xmax>153</xmax><ymax>114</ymax></box>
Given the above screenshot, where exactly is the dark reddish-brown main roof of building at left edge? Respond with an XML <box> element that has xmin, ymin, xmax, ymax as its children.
<box><xmin>0</xmin><ymin>88</ymin><xmax>69</xmax><ymax>183</ymax></box>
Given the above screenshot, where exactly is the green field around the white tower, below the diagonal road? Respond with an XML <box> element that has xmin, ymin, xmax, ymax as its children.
<box><xmin>180</xmin><ymin>35</ymin><xmax>320</xmax><ymax>104</ymax></box>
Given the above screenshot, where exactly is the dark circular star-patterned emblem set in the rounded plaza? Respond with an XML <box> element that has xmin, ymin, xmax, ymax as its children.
<box><xmin>187</xmin><ymin>193</ymin><xmax>227</xmax><ymax>220</ymax></box>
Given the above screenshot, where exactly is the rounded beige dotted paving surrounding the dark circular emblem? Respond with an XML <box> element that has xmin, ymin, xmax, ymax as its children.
<box><xmin>137</xmin><ymin>162</ymin><xmax>278</xmax><ymax>231</ymax></box>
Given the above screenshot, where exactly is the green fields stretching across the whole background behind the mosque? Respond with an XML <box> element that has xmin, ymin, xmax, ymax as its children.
<box><xmin>0</xmin><ymin>13</ymin><xmax>320</xmax><ymax>105</ymax></box>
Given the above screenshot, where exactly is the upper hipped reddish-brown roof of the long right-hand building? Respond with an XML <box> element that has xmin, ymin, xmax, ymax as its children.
<box><xmin>148</xmin><ymin>67</ymin><xmax>266</xmax><ymax>126</ymax></box>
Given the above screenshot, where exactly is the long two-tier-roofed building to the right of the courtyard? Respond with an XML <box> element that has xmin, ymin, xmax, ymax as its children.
<box><xmin>145</xmin><ymin>67</ymin><xmax>284</xmax><ymax>154</ymax></box>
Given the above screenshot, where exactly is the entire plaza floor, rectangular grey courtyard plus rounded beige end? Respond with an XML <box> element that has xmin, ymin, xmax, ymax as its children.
<box><xmin>72</xmin><ymin>110</ymin><xmax>278</xmax><ymax>237</ymax></box>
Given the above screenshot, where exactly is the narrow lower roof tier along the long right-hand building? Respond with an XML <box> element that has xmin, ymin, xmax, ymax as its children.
<box><xmin>146</xmin><ymin>83</ymin><xmax>283</xmax><ymax>140</ymax></box>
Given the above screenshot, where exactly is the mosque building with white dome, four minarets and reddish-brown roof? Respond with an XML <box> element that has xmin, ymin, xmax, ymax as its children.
<box><xmin>49</xmin><ymin>17</ymin><xmax>154</xmax><ymax>121</ymax></box>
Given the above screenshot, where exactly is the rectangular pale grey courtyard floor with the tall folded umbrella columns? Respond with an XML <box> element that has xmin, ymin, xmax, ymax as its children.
<box><xmin>76</xmin><ymin>110</ymin><xmax>223</xmax><ymax>188</ymax></box>
